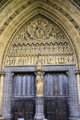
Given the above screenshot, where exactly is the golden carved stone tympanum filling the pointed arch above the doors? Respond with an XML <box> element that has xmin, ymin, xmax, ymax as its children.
<box><xmin>5</xmin><ymin>17</ymin><xmax>75</xmax><ymax>66</ymax></box>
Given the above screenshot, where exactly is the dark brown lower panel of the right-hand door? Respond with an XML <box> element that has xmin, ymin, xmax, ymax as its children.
<box><xmin>44</xmin><ymin>98</ymin><xmax>68</xmax><ymax>120</ymax></box>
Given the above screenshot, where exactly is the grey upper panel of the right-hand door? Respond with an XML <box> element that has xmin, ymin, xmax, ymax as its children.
<box><xmin>44</xmin><ymin>73</ymin><xmax>68</xmax><ymax>96</ymax></box>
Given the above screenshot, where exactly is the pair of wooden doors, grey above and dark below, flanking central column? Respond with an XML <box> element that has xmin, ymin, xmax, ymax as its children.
<box><xmin>12</xmin><ymin>73</ymin><xmax>68</xmax><ymax>120</ymax></box>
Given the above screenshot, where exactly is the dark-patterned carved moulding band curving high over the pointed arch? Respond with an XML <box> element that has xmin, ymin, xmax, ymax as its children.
<box><xmin>0</xmin><ymin>0</ymin><xmax>80</xmax><ymax>35</ymax></box>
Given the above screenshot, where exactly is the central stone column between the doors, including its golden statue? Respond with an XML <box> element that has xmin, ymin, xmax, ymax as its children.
<box><xmin>34</xmin><ymin>60</ymin><xmax>44</xmax><ymax>120</ymax></box>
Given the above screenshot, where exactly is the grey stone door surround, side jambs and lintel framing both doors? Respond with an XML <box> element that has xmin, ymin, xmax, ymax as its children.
<box><xmin>2</xmin><ymin>65</ymin><xmax>79</xmax><ymax>120</ymax></box>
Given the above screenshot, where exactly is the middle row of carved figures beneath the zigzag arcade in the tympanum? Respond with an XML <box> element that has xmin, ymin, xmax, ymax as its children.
<box><xmin>10</xmin><ymin>43</ymin><xmax>69</xmax><ymax>54</ymax></box>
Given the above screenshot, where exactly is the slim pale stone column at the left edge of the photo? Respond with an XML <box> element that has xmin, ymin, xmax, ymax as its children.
<box><xmin>0</xmin><ymin>71</ymin><xmax>5</xmax><ymax>120</ymax></box>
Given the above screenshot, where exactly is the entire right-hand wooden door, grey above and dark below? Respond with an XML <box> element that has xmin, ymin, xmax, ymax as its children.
<box><xmin>44</xmin><ymin>72</ymin><xmax>68</xmax><ymax>120</ymax></box>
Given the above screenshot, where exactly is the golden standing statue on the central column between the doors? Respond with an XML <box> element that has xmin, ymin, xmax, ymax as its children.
<box><xmin>36</xmin><ymin>72</ymin><xmax>43</xmax><ymax>96</ymax></box>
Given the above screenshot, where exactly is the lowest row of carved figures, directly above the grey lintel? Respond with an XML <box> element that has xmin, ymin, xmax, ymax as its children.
<box><xmin>6</xmin><ymin>55</ymin><xmax>75</xmax><ymax>65</ymax></box>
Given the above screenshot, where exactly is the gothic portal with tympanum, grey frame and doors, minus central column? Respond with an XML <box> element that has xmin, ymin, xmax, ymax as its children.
<box><xmin>2</xmin><ymin>16</ymin><xmax>79</xmax><ymax>120</ymax></box>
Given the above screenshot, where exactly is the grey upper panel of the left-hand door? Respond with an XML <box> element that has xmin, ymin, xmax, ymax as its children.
<box><xmin>13</xmin><ymin>73</ymin><xmax>35</xmax><ymax>97</ymax></box>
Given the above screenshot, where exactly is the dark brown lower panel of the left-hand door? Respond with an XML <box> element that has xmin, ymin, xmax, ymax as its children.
<box><xmin>14</xmin><ymin>99</ymin><xmax>35</xmax><ymax>120</ymax></box>
